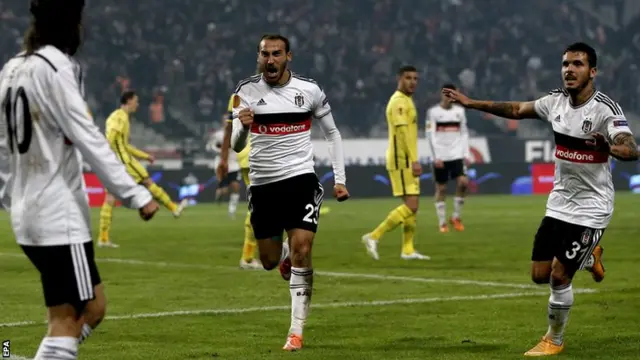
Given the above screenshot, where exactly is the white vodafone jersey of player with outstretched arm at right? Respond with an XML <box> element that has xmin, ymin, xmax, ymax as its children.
<box><xmin>535</xmin><ymin>89</ymin><xmax>631</xmax><ymax>229</ymax></box>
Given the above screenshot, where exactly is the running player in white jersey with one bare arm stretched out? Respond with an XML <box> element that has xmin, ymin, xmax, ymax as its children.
<box><xmin>442</xmin><ymin>43</ymin><xmax>638</xmax><ymax>356</ymax></box>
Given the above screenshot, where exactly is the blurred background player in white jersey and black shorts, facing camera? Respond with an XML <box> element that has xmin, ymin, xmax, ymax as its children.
<box><xmin>425</xmin><ymin>84</ymin><xmax>469</xmax><ymax>233</ymax></box>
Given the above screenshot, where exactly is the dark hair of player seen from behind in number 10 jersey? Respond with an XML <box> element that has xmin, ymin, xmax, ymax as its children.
<box><xmin>24</xmin><ymin>0</ymin><xmax>84</xmax><ymax>55</ymax></box>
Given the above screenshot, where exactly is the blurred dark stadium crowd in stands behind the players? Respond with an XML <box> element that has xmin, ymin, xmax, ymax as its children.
<box><xmin>0</xmin><ymin>0</ymin><xmax>640</xmax><ymax>137</ymax></box>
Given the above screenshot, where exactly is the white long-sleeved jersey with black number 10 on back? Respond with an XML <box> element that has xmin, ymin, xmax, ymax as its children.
<box><xmin>0</xmin><ymin>46</ymin><xmax>152</xmax><ymax>246</ymax></box>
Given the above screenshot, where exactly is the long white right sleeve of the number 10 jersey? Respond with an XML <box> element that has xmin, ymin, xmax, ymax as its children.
<box><xmin>49</xmin><ymin>66</ymin><xmax>152</xmax><ymax>209</ymax></box>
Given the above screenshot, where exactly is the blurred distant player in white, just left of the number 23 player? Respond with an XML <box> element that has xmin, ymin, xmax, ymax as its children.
<box><xmin>208</xmin><ymin>113</ymin><xmax>242</xmax><ymax>219</ymax></box>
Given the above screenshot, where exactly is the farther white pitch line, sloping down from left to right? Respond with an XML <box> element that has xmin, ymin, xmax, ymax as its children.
<box><xmin>0</xmin><ymin>253</ymin><xmax>593</xmax><ymax>290</ymax></box>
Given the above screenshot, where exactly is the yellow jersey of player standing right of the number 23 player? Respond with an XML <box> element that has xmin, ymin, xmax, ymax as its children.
<box><xmin>386</xmin><ymin>91</ymin><xmax>418</xmax><ymax>170</ymax></box>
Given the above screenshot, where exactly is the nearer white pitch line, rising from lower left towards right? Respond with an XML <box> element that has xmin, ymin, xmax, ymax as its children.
<box><xmin>0</xmin><ymin>289</ymin><xmax>596</xmax><ymax>328</ymax></box>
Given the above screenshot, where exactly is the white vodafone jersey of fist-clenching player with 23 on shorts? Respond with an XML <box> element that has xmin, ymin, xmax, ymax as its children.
<box><xmin>233</xmin><ymin>72</ymin><xmax>346</xmax><ymax>185</ymax></box>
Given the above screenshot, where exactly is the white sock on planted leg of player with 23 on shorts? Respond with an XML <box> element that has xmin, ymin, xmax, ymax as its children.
<box><xmin>289</xmin><ymin>267</ymin><xmax>313</xmax><ymax>336</ymax></box>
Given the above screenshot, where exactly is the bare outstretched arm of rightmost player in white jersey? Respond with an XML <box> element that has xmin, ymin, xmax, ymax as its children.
<box><xmin>442</xmin><ymin>89</ymin><xmax>540</xmax><ymax>120</ymax></box>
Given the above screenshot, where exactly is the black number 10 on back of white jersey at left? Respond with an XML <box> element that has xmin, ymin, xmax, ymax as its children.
<box><xmin>2</xmin><ymin>87</ymin><xmax>33</xmax><ymax>154</ymax></box>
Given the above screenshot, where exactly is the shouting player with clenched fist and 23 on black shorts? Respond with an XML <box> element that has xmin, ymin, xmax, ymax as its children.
<box><xmin>231</xmin><ymin>35</ymin><xmax>349</xmax><ymax>351</ymax></box>
